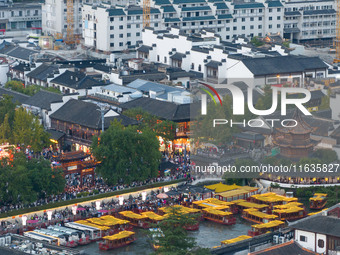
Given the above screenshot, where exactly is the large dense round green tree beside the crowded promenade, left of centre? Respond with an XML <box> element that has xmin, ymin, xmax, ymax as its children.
<box><xmin>92</xmin><ymin>121</ymin><xmax>161</xmax><ymax>184</ymax></box>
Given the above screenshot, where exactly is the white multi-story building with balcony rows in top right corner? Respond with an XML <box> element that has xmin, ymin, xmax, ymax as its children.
<box><xmin>284</xmin><ymin>0</ymin><xmax>336</xmax><ymax>44</ymax></box>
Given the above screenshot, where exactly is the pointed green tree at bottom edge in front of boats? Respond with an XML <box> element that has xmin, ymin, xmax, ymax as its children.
<box><xmin>153</xmin><ymin>207</ymin><xmax>203</xmax><ymax>255</ymax></box>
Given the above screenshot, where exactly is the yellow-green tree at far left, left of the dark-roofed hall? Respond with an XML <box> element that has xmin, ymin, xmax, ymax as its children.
<box><xmin>12</xmin><ymin>108</ymin><xmax>49</xmax><ymax>151</ymax></box>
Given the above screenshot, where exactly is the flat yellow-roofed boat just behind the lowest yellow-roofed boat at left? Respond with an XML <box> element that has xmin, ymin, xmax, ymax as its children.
<box><xmin>87</xmin><ymin>215</ymin><xmax>132</xmax><ymax>235</ymax></box>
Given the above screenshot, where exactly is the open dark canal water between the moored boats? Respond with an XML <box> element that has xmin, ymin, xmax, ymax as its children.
<box><xmin>76</xmin><ymin>217</ymin><xmax>252</xmax><ymax>255</ymax></box>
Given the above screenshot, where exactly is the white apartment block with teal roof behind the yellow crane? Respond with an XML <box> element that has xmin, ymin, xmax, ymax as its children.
<box><xmin>83</xmin><ymin>4</ymin><xmax>162</xmax><ymax>52</ymax></box>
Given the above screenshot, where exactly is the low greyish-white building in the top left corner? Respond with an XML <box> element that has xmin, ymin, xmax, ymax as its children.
<box><xmin>0</xmin><ymin>0</ymin><xmax>41</xmax><ymax>33</ymax></box>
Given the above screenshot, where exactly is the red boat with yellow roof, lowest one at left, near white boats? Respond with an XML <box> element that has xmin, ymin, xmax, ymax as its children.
<box><xmin>99</xmin><ymin>230</ymin><xmax>136</xmax><ymax>251</ymax></box>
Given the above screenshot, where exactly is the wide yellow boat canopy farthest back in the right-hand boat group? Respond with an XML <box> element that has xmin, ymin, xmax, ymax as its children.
<box><xmin>249</xmin><ymin>192</ymin><xmax>298</xmax><ymax>209</ymax></box>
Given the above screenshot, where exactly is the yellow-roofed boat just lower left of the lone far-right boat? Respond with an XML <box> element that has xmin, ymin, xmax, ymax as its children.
<box><xmin>273</xmin><ymin>202</ymin><xmax>307</xmax><ymax>221</ymax></box>
